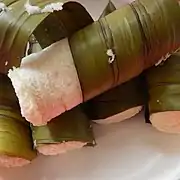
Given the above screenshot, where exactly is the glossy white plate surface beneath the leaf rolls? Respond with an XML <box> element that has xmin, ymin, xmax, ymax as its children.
<box><xmin>0</xmin><ymin>0</ymin><xmax>180</xmax><ymax>180</ymax></box>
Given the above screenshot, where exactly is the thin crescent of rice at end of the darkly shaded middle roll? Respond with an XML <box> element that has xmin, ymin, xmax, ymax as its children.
<box><xmin>94</xmin><ymin>106</ymin><xmax>142</xmax><ymax>125</ymax></box>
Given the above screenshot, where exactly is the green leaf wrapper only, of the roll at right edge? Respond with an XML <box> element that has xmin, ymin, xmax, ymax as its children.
<box><xmin>146</xmin><ymin>52</ymin><xmax>180</xmax><ymax>115</ymax></box>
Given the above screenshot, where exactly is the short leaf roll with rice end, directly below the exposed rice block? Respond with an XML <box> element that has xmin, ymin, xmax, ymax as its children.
<box><xmin>32</xmin><ymin>107</ymin><xmax>94</xmax><ymax>155</ymax></box>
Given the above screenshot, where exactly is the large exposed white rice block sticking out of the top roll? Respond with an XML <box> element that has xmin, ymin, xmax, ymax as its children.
<box><xmin>8</xmin><ymin>39</ymin><xmax>82</xmax><ymax>126</ymax></box>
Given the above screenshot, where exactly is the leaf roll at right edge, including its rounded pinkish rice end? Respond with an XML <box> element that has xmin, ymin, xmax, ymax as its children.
<box><xmin>146</xmin><ymin>52</ymin><xmax>180</xmax><ymax>133</ymax></box>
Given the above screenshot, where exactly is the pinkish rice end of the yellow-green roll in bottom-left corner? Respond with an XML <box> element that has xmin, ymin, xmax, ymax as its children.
<box><xmin>0</xmin><ymin>155</ymin><xmax>30</xmax><ymax>168</ymax></box>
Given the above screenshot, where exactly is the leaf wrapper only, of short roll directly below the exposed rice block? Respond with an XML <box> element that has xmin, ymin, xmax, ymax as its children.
<box><xmin>32</xmin><ymin>107</ymin><xmax>94</xmax><ymax>147</ymax></box>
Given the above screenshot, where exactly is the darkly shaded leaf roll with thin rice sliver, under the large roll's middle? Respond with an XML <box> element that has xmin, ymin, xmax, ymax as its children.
<box><xmin>85</xmin><ymin>77</ymin><xmax>146</xmax><ymax>124</ymax></box>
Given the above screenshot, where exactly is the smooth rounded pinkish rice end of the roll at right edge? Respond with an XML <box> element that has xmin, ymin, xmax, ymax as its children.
<box><xmin>150</xmin><ymin>111</ymin><xmax>180</xmax><ymax>134</ymax></box>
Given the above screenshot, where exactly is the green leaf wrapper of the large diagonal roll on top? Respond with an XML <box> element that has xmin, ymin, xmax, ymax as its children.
<box><xmin>70</xmin><ymin>0</ymin><xmax>180</xmax><ymax>101</ymax></box>
